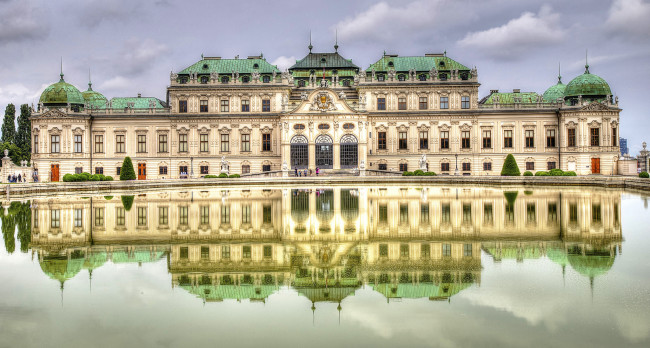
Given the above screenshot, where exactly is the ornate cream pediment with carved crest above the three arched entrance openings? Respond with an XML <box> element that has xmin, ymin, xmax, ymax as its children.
<box><xmin>289</xmin><ymin>88</ymin><xmax>357</xmax><ymax>114</ymax></box>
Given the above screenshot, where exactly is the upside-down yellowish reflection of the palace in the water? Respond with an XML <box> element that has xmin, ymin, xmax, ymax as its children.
<box><xmin>32</xmin><ymin>187</ymin><xmax>622</xmax><ymax>302</ymax></box>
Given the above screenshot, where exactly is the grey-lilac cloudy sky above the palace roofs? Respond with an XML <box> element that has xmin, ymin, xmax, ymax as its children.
<box><xmin>0</xmin><ymin>0</ymin><xmax>650</xmax><ymax>153</ymax></box>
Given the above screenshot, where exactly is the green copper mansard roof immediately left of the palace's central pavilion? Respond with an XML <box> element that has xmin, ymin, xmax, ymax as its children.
<box><xmin>178</xmin><ymin>58</ymin><xmax>280</xmax><ymax>75</ymax></box>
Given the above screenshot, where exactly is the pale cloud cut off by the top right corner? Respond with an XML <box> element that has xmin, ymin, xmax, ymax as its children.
<box><xmin>605</xmin><ymin>0</ymin><xmax>650</xmax><ymax>38</ymax></box>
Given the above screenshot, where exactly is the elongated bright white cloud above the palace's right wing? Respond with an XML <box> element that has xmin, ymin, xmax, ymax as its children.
<box><xmin>458</xmin><ymin>6</ymin><xmax>565</xmax><ymax>59</ymax></box>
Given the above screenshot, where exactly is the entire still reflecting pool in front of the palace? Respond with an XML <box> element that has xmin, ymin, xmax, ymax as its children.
<box><xmin>0</xmin><ymin>186</ymin><xmax>650</xmax><ymax>347</ymax></box>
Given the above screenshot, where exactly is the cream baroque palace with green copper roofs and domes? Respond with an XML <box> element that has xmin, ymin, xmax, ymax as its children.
<box><xmin>32</xmin><ymin>44</ymin><xmax>621</xmax><ymax>181</ymax></box>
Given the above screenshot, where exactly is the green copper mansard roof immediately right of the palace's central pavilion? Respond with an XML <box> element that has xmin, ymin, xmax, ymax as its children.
<box><xmin>366</xmin><ymin>55</ymin><xmax>470</xmax><ymax>72</ymax></box>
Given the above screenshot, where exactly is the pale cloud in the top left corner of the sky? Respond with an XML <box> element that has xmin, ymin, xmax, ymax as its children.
<box><xmin>0</xmin><ymin>1</ymin><xmax>50</xmax><ymax>44</ymax></box>
